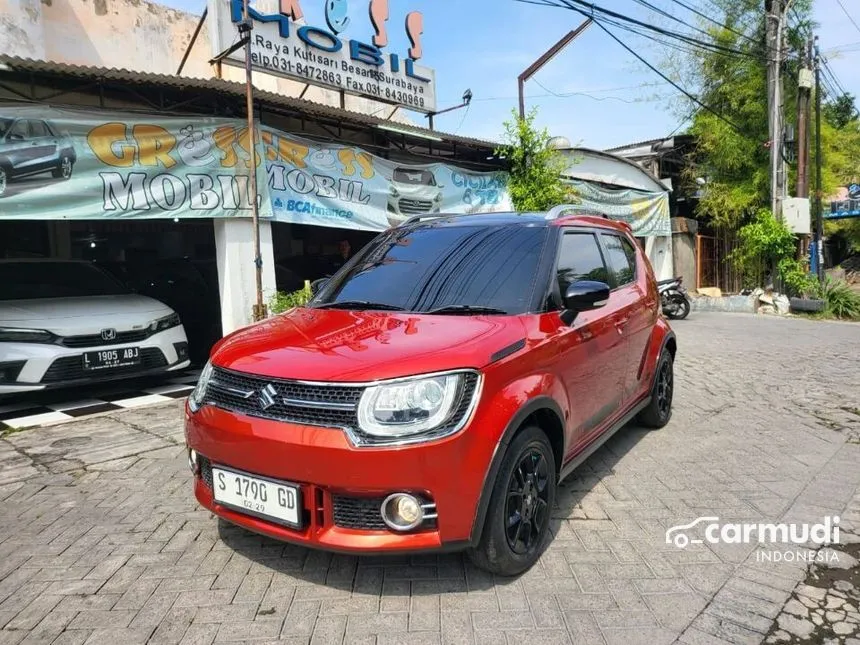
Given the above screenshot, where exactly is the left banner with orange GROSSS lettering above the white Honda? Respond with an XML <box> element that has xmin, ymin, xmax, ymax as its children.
<box><xmin>0</xmin><ymin>106</ymin><xmax>271</xmax><ymax>219</ymax></box>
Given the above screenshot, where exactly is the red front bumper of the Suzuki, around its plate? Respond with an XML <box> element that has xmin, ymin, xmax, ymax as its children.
<box><xmin>185</xmin><ymin>406</ymin><xmax>495</xmax><ymax>553</ymax></box>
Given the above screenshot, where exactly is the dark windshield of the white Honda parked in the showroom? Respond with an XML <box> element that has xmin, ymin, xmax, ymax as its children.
<box><xmin>0</xmin><ymin>262</ymin><xmax>129</xmax><ymax>300</ymax></box>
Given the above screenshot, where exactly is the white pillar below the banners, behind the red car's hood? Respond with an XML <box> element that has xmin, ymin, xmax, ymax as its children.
<box><xmin>213</xmin><ymin>217</ymin><xmax>275</xmax><ymax>336</ymax></box>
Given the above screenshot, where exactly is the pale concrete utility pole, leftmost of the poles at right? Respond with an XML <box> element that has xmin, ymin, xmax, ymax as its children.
<box><xmin>765</xmin><ymin>0</ymin><xmax>791</xmax><ymax>219</ymax></box>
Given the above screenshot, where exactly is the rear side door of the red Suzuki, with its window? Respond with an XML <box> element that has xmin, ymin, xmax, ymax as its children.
<box><xmin>600</xmin><ymin>232</ymin><xmax>655</xmax><ymax>407</ymax></box>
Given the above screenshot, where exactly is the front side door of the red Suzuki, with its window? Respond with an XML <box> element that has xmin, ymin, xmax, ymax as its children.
<box><xmin>556</xmin><ymin>229</ymin><xmax>626</xmax><ymax>458</ymax></box>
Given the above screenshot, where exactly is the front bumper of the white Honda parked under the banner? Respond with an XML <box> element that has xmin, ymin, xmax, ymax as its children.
<box><xmin>0</xmin><ymin>325</ymin><xmax>190</xmax><ymax>395</ymax></box>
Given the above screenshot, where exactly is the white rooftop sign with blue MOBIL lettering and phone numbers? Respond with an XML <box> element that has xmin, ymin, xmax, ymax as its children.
<box><xmin>209</xmin><ymin>0</ymin><xmax>436</xmax><ymax>112</ymax></box>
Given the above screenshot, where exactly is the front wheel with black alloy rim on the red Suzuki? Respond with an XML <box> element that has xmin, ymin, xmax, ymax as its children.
<box><xmin>468</xmin><ymin>426</ymin><xmax>557</xmax><ymax>576</ymax></box>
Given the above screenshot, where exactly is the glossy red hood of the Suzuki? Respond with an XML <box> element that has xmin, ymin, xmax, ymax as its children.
<box><xmin>212</xmin><ymin>308</ymin><xmax>526</xmax><ymax>382</ymax></box>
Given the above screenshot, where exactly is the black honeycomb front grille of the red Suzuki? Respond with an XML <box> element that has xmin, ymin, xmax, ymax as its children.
<box><xmin>206</xmin><ymin>367</ymin><xmax>364</xmax><ymax>428</ymax></box>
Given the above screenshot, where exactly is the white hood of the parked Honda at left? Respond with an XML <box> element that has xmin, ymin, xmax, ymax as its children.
<box><xmin>0</xmin><ymin>294</ymin><xmax>173</xmax><ymax>336</ymax></box>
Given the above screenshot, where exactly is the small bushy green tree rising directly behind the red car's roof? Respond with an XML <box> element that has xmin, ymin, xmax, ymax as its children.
<box><xmin>496</xmin><ymin>109</ymin><xmax>576</xmax><ymax>211</ymax></box>
